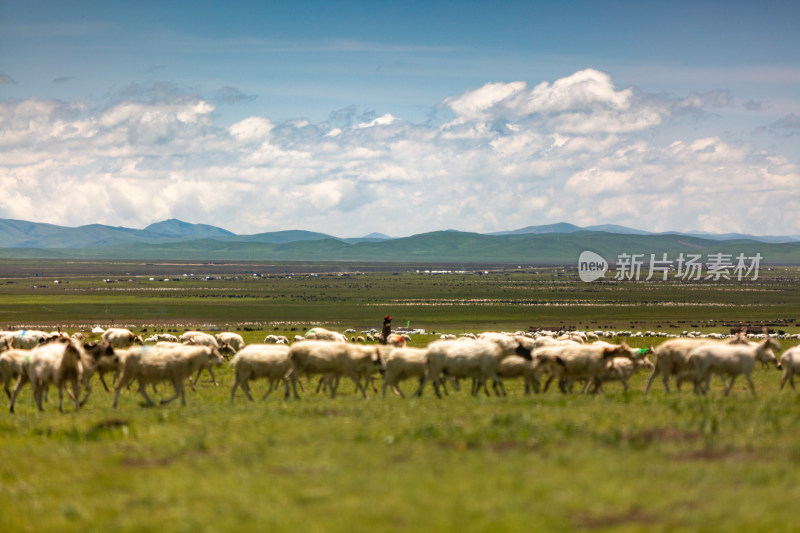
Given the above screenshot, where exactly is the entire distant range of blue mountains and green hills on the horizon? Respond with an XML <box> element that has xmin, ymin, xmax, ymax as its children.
<box><xmin>0</xmin><ymin>219</ymin><xmax>800</xmax><ymax>264</ymax></box>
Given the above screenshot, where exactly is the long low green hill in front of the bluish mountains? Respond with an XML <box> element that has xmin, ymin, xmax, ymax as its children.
<box><xmin>0</xmin><ymin>231</ymin><xmax>800</xmax><ymax>264</ymax></box>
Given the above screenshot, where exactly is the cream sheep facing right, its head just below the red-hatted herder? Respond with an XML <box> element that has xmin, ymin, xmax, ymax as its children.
<box><xmin>289</xmin><ymin>340</ymin><xmax>385</xmax><ymax>398</ymax></box>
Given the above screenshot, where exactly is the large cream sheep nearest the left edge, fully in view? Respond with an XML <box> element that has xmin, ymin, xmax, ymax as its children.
<box><xmin>8</xmin><ymin>339</ymin><xmax>83</xmax><ymax>413</ymax></box>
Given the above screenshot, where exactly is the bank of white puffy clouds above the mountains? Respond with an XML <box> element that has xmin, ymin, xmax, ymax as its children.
<box><xmin>0</xmin><ymin>70</ymin><xmax>800</xmax><ymax>236</ymax></box>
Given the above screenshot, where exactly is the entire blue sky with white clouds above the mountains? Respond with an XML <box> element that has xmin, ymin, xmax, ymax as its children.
<box><xmin>0</xmin><ymin>0</ymin><xmax>800</xmax><ymax>236</ymax></box>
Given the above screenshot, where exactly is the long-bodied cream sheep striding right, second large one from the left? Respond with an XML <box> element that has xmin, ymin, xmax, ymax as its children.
<box><xmin>112</xmin><ymin>345</ymin><xmax>222</xmax><ymax>408</ymax></box>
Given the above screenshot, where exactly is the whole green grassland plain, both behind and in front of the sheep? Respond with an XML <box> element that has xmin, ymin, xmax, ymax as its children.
<box><xmin>0</xmin><ymin>263</ymin><xmax>800</xmax><ymax>532</ymax></box>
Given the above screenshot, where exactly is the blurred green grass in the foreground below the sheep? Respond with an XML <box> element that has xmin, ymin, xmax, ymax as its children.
<box><xmin>0</xmin><ymin>368</ymin><xmax>800</xmax><ymax>532</ymax></box>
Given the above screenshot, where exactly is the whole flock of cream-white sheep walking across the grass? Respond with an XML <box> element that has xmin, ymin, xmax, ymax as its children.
<box><xmin>0</xmin><ymin>328</ymin><xmax>800</xmax><ymax>413</ymax></box>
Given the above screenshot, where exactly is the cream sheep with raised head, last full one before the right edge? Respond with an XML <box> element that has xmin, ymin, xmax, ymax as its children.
<box><xmin>689</xmin><ymin>337</ymin><xmax>781</xmax><ymax>396</ymax></box>
